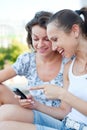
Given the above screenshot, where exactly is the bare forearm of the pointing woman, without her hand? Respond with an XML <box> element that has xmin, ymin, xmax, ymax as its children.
<box><xmin>61</xmin><ymin>91</ymin><xmax>87</xmax><ymax>116</ymax></box>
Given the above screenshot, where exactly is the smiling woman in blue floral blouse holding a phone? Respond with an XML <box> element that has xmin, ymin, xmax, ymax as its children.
<box><xmin>0</xmin><ymin>11</ymin><xmax>68</xmax><ymax>122</ymax></box>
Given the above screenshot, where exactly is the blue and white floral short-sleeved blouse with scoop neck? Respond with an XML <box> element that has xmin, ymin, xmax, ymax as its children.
<box><xmin>12</xmin><ymin>52</ymin><xmax>68</xmax><ymax>107</ymax></box>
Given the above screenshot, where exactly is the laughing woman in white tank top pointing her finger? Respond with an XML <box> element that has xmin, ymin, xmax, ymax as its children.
<box><xmin>1</xmin><ymin>8</ymin><xmax>87</xmax><ymax>130</ymax></box>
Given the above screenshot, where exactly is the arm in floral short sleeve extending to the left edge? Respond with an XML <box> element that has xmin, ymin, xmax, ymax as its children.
<box><xmin>0</xmin><ymin>53</ymin><xmax>30</xmax><ymax>83</ymax></box>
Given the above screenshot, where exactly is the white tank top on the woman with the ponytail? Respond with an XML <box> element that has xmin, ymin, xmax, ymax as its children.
<box><xmin>68</xmin><ymin>59</ymin><xmax>87</xmax><ymax>124</ymax></box>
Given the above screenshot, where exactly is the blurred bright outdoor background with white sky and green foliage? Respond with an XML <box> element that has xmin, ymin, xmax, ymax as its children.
<box><xmin>0</xmin><ymin>0</ymin><xmax>87</xmax><ymax>87</ymax></box>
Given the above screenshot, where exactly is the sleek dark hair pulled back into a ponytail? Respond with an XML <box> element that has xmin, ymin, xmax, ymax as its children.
<box><xmin>48</xmin><ymin>7</ymin><xmax>87</xmax><ymax>37</ymax></box>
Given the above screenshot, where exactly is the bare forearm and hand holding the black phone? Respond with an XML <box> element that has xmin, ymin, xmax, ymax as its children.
<box><xmin>16</xmin><ymin>95</ymin><xmax>70</xmax><ymax>119</ymax></box>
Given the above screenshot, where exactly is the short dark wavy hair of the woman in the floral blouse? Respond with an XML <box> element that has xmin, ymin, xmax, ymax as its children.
<box><xmin>25</xmin><ymin>11</ymin><xmax>52</xmax><ymax>47</ymax></box>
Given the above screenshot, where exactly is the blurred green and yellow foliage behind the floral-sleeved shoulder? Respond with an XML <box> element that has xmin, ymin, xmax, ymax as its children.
<box><xmin>0</xmin><ymin>39</ymin><xmax>30</xmax><ymax>69</ymax></box>
